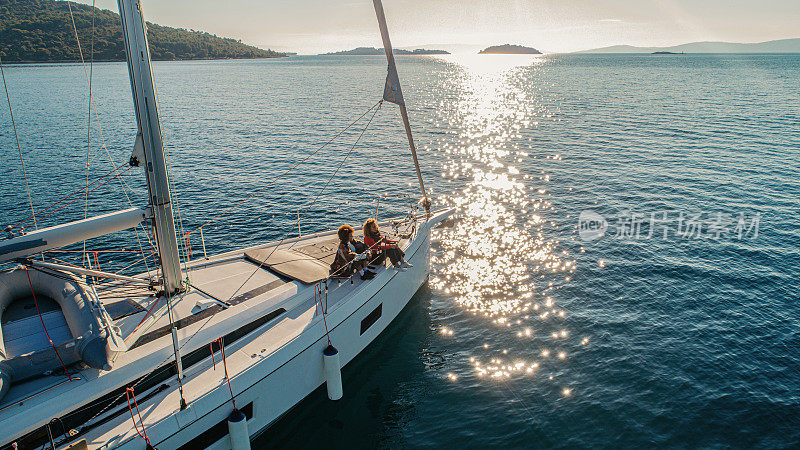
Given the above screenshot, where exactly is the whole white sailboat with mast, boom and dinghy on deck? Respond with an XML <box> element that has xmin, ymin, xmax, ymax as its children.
<box><xmin>0</xmin><ymin>0</ymin><xmax>452</xmax><ymax>449</ymax></box>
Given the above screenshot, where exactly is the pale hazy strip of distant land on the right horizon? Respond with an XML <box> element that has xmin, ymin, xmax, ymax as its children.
<box><xmin>576</xmin><ymin>38</ymin><xmax>800</xmax><ymax>55</ymax></box>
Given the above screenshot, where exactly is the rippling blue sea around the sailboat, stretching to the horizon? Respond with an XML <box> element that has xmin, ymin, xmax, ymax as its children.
<box><xmin>0</xmin><ymin>55</ymin><xmax>800</xmax><ymax>448</ymax></box>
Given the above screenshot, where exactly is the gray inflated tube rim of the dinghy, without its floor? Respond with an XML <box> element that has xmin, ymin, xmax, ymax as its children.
<box><xmin>0</xmin><ymin>266</ymin><xmax>124</xmax><ymax>401</ymax></box>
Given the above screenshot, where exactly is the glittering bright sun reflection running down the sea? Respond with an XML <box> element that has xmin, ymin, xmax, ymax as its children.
<box><xmin>430</xmin><ymin>53</ymin><xmax>588</xmax><ymax>396</ymax></box>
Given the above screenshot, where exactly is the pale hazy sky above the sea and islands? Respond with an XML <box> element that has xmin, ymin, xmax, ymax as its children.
<box><xmin>80</xmin><ymin>0</ymin><xmax>800</xmax><ymax>54</ymax></box>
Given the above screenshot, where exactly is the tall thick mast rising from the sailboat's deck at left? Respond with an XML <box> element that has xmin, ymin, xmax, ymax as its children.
<box><xmin>118</xmin><ymin>0</ymin><xmax>182</xmax><ymax>294</ymax></box>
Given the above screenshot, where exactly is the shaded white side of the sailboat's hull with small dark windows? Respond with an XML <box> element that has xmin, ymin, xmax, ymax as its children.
<box><xmin>114</xmin><ymin>217</ymin><xmax>430</xmax><ymax>450</ymax></box>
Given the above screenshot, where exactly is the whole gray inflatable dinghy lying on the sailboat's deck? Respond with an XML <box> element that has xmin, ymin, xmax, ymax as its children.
<box><xmin>0</xmin><ymin>266</ymin><xmax>124</xmax><ymax>400</ymax></box>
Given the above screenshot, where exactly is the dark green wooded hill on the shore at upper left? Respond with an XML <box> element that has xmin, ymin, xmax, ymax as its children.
<box><xmin>0</xmin><ymin>0</ymin><xmax>286</xmax><ymax>62</ymax></box>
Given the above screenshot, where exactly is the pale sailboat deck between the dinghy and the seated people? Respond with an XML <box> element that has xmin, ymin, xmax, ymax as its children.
<box><xmin>0</xmin><ymin>217</ymin><xmax>413</xmax><ymax>444</ymax></box>
